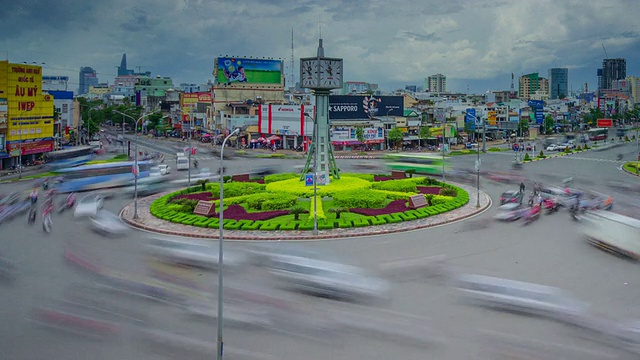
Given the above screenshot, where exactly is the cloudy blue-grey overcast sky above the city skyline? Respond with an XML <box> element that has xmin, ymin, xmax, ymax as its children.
<box><xmin>0</xmin><ymin>0</ymin><xmax>640</xmax><ymax>93</ymax></box>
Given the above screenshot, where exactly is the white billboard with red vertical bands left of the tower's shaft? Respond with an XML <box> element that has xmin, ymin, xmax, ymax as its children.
<box><xmin>258</xmin><ymin>105</ymin><xmax>314</xmax><ymax>136</ymax></box>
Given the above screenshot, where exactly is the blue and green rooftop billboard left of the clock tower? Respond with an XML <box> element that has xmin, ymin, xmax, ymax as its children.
<box><xmin>214</xmin><ymin>57</ymin><xmax>282</xmax><ymax>85</ymax></box>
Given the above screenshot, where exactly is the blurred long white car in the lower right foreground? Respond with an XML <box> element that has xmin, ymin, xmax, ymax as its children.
<box><xmin>455</xmin><ymin>274</ymin><xmax>589</xmax><ymax>323</ymax></box>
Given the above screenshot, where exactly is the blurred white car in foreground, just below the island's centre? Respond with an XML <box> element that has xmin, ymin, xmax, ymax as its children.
<box><xmin>268</xmin><ymin>255</ymin><xmax>389</xmax><ymax>302</ymax></box>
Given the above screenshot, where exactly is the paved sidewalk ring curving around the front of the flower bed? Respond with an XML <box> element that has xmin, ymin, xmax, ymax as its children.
<box><xmin>120</xmin><ymin>184</ymin><xmax>492</xmax><ymax>241</ymax></box>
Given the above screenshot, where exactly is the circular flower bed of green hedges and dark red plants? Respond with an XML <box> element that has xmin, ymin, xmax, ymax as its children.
<box><xmin>150</xmin><ymin>174</ymin><xmax>469</xmax><ymax>231</ymax></box>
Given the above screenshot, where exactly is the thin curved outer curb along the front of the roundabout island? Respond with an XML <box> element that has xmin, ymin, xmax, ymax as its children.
<box><xmin>119</xmin><ymin>191</ymin><xmax>493</xmax><ymax>241</ymax></box>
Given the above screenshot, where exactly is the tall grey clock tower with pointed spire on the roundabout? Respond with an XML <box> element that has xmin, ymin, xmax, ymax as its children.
<box><xmin>300</xmin><ymin>39</ymin><xmax>343</xmax><ymax>185</ymax></box>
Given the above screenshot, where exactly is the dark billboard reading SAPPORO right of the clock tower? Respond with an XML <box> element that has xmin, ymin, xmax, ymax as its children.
<box><xmin>329</xmin><ymin>95</ymin><xmax>404</xmax><ymax>120</ymax></box>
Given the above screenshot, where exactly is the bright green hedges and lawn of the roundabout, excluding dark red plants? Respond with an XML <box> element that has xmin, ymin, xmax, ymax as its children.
<box><xmin>150</xmin><ymin>174</ymin><xmax>469</xmax><ymax>231</ymax></box>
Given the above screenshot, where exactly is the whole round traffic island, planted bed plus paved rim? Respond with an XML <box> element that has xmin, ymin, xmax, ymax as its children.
<box><xmin>121</xmin><ymin>173</ymin><xmax>491</xmax><ymax>240</ymax></box>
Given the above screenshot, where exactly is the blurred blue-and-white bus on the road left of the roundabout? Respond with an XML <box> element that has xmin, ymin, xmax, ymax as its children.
<box><xmin>55</xmin><ymin>161</ymin><xmax>152</xmax><ymax>193</ymax></box>
